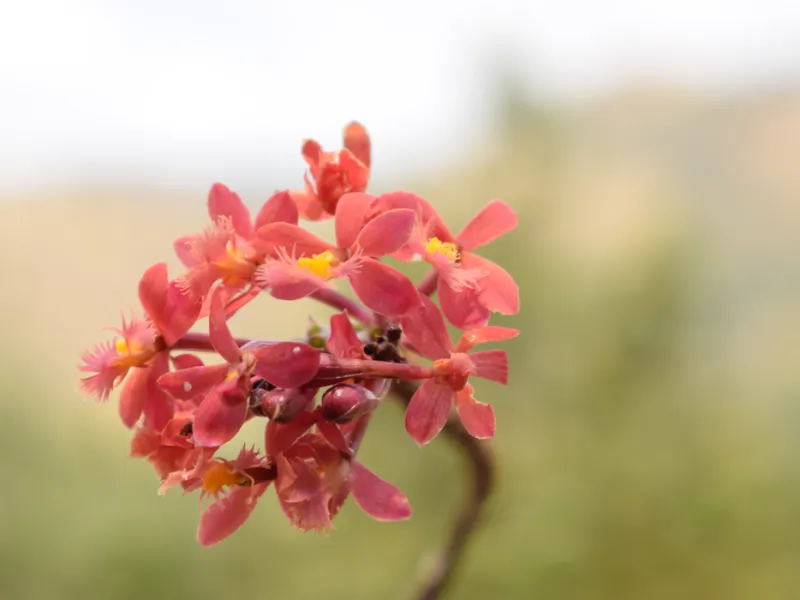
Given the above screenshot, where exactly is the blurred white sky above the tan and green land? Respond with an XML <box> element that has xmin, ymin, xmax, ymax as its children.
<box><xmin>0</xmin><ymin>0</ymin><xmax>800</xmax><ymax>195</ymax></box>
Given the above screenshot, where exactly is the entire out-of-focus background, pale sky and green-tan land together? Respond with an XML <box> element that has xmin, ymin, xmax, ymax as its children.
<box><xmin>0</xmin><ymin>0</ymin><xmax>800</xmax><ymax>600</ymax></box>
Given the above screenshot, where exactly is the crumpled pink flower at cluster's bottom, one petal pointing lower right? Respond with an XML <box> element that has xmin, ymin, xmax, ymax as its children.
<box><xmin>267</xmin><ymin>411</ymin><xmax>411</xmax><ymax>531</ymax></box>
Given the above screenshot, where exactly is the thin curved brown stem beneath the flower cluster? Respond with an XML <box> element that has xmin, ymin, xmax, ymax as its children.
<box><xmin>392</xmin><ymin>381</ymin><xmax>495</xmax><ymax>600</ymax></box>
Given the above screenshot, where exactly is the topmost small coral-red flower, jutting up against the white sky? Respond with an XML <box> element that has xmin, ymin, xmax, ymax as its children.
<box><xmin>291</xmin><ymin>122</ymin><xmax>371</xmax><ymax>221</ymax></box>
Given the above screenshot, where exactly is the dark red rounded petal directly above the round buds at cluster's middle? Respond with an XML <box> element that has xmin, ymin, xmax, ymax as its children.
<box><xmin>250</xmin><ymin>342</ymin><xmax>320</xmax><ymax>388</ymax></box>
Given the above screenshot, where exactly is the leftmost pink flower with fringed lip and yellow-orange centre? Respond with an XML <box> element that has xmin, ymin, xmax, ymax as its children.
<box><xmin>79</xmin><ymin>263</ymin><xmax>200</xmax><ymax>429</ymax></box>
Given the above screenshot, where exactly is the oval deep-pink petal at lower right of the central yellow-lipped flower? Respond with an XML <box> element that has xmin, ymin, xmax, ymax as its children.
<box><xmin>350</xmin><ymin>257</ymin><xmax>419</xmax><ymax>317</ymax></box>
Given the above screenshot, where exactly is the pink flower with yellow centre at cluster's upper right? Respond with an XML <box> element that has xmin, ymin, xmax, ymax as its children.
<box><xmin>372</xmin><ymin>192</ymin><xmax>519</xmax><ymax>329</ymax></box>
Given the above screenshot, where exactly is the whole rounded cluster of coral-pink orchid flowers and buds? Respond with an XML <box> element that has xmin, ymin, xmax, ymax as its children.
<box><xmin>79</xmin><ymin>123</ymin><xmax>519</xmax><ymax>545</ymax></box>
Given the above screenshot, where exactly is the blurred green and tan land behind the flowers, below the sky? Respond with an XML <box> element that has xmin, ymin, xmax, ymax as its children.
<box><xmin>0</xmin><ymin>88</ymin><xmax>800</xmax><ymax>600</ymax></box>
